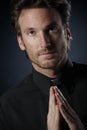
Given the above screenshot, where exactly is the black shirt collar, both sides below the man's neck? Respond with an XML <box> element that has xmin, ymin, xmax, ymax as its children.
<box><xmin>33</xmin><ymin>60</ymin><xmax>73</xmax><ymax>95</ymax></box>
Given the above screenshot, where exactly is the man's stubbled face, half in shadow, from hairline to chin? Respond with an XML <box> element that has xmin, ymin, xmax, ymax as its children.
<box><xmin>18</xmin><ymin>8</ymin><xmax>69</xmax><ymax>69</ymax></box>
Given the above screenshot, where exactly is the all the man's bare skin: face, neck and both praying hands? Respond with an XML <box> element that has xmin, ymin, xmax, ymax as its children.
<box><xmin>17</xmin><ymin>8</ymin><xmax>84</xmax><ymax>130</ymax></box>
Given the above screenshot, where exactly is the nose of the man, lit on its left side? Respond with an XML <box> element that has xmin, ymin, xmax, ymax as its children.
<box><xmin>40</xmin><ymin>32</ymin><xmax>51</xmax><ymax>48</ymax></box>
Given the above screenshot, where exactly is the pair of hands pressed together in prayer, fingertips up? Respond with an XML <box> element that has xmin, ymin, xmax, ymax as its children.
<box><xmin>47</xmin><ymin>86</ymin><xmax>85</xmax><ymax>130</ymax></box>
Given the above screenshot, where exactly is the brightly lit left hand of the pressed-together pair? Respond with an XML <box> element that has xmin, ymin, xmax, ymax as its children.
<box><xmin>47</xmin><ymin>87</ymin><xmax>61</xmax><ymax>130</ymax></box>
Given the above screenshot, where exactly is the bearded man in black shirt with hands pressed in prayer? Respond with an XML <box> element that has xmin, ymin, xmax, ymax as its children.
<box><xmin>0</xmin><ymin>0</ymin><xmax>87</xmax><ymax>130</ymax></box>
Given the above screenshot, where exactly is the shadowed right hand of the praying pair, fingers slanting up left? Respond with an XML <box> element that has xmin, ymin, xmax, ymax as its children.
<box><xmin>54</xmin><ymin>87</ymin><xmax>85</xmax><ymax>130</ymax></box>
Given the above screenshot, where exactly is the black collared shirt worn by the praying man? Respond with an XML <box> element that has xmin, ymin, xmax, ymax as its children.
<box><xmin>0</xmin><ymin>62</ymin><xmax>87</xmax><ymax>130</ymax></box>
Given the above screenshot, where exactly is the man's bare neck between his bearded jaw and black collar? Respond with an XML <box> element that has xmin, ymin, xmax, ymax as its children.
<box><xmin>32</xmin><ymin>56</ymin><xmax>68</xmax><ymax>78</ymax></box>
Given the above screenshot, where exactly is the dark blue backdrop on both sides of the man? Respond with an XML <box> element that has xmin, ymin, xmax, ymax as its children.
<box><xmin>0</xmin><ymin>0</ymin><xmax>87</xmax><ymax>93</ymax></box>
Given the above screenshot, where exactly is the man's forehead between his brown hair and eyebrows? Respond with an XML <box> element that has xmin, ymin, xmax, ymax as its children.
<box><xmin>19</xmin><ymin>8</ymin><xmax>61</xmax><ymax>28</ymax></box>
